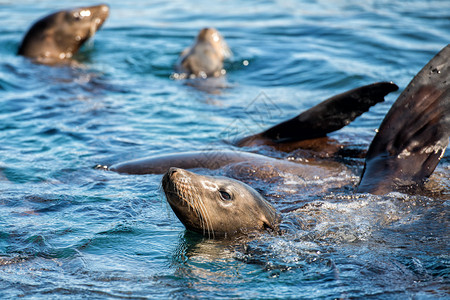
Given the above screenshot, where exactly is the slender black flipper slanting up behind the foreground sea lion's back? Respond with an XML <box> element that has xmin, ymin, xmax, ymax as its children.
<box><xmin>237</xmin><ymin>82</ymin><xmax>398</xmax><ymax>146</ymax></box>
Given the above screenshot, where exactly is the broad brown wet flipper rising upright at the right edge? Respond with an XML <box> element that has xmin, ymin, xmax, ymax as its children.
<box><xmin>358</xmin><ymin>45</ymin><xmax>450</xmax><ymax>194</ymax></box>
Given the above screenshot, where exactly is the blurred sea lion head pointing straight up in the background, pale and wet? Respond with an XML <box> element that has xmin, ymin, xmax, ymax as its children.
<box><xmin>174</xmin><ymin>28</ymin><xmax>231</xmax><ymax>79</ymax></box>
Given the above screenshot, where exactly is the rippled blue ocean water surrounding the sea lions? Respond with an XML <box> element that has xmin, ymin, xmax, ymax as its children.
<box><xmin>0</xmin><ymin>0</ymin><xmax>450</xmax><ymax>299</ymax></box>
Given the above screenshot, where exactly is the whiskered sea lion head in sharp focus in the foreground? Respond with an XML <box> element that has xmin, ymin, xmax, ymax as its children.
<box><xmin>162</xmin><ymin>168</ymin><xmax>279</xmax><ymax>237</ymax></box>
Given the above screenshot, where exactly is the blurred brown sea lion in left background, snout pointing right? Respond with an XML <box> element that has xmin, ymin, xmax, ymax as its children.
<box><xmin>18</xmin><ymin>4</ymin><xmax>109</xmax><ymax>64</ymax></box>
